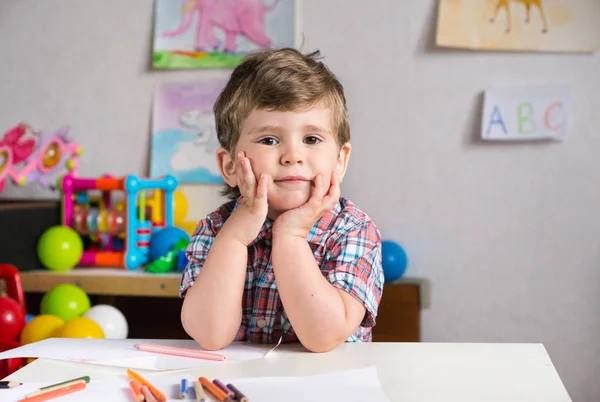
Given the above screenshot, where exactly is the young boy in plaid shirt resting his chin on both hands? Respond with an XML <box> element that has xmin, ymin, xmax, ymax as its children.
<box><xmin>180</xmin><ymin>48</ymin><xmax>384</xmax><ymax>352</ymax></box>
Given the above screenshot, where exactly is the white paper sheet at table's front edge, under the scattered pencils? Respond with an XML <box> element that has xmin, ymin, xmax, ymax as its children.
<box><xmin>0</xmin><ymin>366</ymin><xmax>389</xmax><ymax>402</ymax></box>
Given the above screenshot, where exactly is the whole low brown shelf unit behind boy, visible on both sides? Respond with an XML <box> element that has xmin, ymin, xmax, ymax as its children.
<box><xmin>20</xmin><ymin>268</ymin><xmax>429</xmax><ymax>342</ymax></box>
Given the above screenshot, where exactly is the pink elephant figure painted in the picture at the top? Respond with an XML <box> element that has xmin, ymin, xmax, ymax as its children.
<box><xmin>163</xmin><ymin>0</ymin><xmax>279</xmax><ymax>53</ymax></box>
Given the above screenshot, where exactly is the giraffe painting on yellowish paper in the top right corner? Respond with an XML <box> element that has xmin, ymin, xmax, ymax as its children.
<box><xmin>436</xmin><ymin>0</ymin><xmax>600</xmax><ymax>52</ymax></box>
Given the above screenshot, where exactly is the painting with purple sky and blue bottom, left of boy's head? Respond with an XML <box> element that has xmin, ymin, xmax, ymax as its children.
<box><xmin>150</xmin><ymin>80</ymin><xmax>225</xmax><ymax>183</ymax></box>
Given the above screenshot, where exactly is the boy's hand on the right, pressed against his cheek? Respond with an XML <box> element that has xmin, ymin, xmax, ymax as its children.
<box><xmin>273</xmin><ymin>172</ymin><xmax>340</xmax><ymax>239</ymax></box>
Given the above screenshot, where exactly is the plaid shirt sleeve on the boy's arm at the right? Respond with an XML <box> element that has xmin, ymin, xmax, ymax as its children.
<box><xmin>326</xmin><ymin>221</ymin><xmax>384</xmax><ymax>327</ymax></box>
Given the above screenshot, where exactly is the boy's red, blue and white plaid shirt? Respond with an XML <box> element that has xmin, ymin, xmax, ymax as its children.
<box><xmin>179</xmin><ymin>198</ymin><xmax>384</xmax><ymax>343</ymax></box>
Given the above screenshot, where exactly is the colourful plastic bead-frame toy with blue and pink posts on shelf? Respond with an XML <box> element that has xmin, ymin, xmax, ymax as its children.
<box><xmin>61</xmin><ymin>174</ymin><xmax>177</xmax><ymax>270</ymax></box>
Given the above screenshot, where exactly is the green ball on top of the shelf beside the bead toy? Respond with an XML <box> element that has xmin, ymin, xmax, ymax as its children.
<box><xmin>37</xmin><ymin>226</ymin><xmax>83</xmax><ymax>271</ymax></box>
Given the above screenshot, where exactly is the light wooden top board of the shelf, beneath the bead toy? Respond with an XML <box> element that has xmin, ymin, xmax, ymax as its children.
<box><xmin>20</xmin><ymin>268</ymin><xmax>181</xmax><ymax>297</ymax></box>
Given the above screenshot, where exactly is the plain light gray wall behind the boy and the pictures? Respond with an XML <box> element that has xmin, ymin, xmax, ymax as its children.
<box><xmin>0</xmin><ymin>0</ymin><xmax>600</xmax><ymax>401</ymax></box>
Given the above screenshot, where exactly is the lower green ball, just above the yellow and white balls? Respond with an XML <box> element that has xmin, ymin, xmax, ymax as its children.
<box><xmin>40</xmin><ymin>283</ymin><xmax>91</xmax><ymax>322</ymax></box>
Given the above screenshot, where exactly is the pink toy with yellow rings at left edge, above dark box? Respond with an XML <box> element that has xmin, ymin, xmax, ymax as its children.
<box><xmin>0</xmin><ymin>124</ymin><xmax>82</xmax><ymax>193</ymax></box>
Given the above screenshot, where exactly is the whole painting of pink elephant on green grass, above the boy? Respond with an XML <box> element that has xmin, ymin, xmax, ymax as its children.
<box><xmin>152</xmin><ymin>0</ymin><xmax>296</xmax><ymax>69</ymax></box>
